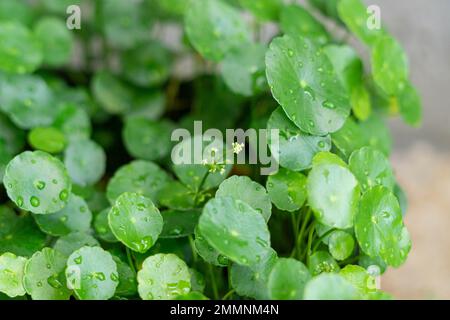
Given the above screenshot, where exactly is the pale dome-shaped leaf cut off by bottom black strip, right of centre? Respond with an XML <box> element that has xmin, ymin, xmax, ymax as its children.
<box><xmin>304</xmin><ymin>273</ymin><xmax>360</xmax><ymax>300</ymax></box>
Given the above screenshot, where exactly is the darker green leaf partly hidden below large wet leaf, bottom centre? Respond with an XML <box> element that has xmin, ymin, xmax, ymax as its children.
<box><xmin>230</xmin><ymin>250</ymin><xmax>277</xmax><ymax>299</ymax></box>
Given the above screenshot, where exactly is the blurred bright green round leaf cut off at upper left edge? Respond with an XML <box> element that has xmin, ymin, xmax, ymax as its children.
<box><xmin>0</xmin><ymin>21</ymin><xmax>43</xmax><ymax>74</ymax></box>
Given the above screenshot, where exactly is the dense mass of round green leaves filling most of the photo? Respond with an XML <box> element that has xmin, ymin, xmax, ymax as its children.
<box><xmin>0</xmin><ymin>0</ymin><xmax>421</xmax><ymax>300</ymax></box>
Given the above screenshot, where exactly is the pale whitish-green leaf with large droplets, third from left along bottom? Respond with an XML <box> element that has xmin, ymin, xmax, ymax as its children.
<box><xmin>66</xmin><ymin>247</ymin><xmax>119</xmax><ymax>300</ymax></box>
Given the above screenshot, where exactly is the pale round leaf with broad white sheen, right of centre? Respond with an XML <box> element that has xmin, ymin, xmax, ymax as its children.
<box><xmin>307</xmin><ymin>164</ymin><xmax>359</xmax><ymax>229</ymax></box>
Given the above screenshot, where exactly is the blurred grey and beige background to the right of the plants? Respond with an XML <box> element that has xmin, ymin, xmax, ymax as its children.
<box><xmin>365</xmin><ymin>0</ymin><xmax>450</xmax><ymax>299</ymax></box>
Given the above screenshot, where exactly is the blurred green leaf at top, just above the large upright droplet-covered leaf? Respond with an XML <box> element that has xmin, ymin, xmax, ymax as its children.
<box><xmin>280</xmin><ymin>5</ymin><xmax>330</xmax><ymax>44</ymax></box>
